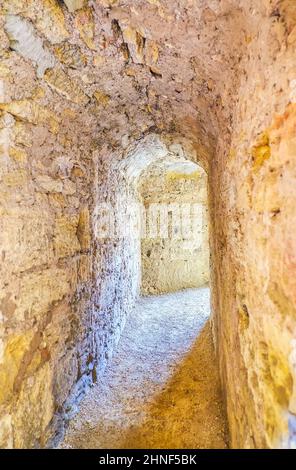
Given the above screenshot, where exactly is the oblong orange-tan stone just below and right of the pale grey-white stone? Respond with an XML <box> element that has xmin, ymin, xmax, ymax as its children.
<box><xmin>44</xmin><ymin>68</ymin><xmax>89</xmax><ymax>105</ymax></box>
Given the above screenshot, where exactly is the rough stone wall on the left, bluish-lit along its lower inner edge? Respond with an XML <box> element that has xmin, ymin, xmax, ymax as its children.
<box><xmin>0</xmin><ymin>0</ymin><xmax>140</xmax><ymax>448</ymax></box>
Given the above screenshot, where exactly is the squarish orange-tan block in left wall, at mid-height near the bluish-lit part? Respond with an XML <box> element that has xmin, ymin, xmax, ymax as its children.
<box><xmin>54</xmin><ymin>216</ymin><xmax>81</xmax><ymax>258</ymax></box>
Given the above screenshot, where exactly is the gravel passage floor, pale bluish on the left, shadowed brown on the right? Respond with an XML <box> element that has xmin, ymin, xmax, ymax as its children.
<box><xmin>61</xmin><ymin>287</ymin><xmax>227</xmax><ymax>449</ymax></box>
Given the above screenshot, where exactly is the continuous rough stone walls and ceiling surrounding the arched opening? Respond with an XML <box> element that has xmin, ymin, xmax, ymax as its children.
<box><xmin>0</xmin><ymin>0</ymin><xmax>296</xmax><ymax>447</ymax></box>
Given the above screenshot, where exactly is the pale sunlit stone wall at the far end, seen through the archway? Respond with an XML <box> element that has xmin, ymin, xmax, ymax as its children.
<box><xmin>139</xmin><ymin>161</ymin><xmax>209</xmax><ymax>295</ymax></box>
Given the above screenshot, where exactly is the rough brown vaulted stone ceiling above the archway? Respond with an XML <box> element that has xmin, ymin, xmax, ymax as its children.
<box><xmin>1</xmin><ymin>0</ymin><xmax>252</xmax><ymax>162</ymax></box>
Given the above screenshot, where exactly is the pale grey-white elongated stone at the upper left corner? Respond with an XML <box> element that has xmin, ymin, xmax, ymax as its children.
<box><xmin>5</xmin><ymin>15</ymin><xmax>55</xmax><ymax>77</ymax></box>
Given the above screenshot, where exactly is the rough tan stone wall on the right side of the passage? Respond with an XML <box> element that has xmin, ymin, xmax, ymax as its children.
<box><xmin>210</xmin><ymin>1</ymin><xmax>296</xmax><ymax>448</ymax></box>
